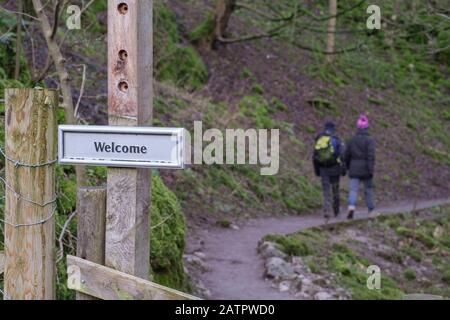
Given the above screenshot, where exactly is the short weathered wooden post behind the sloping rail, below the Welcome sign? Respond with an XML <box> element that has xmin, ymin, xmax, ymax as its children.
<box><xmin>77</xmin><ymin>187</ymin><xmax>106</xmax><ymax>300</ymax></box>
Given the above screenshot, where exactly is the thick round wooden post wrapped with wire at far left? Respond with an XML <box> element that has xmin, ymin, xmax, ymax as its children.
<box><xmin>4</xmin><ymin>89</ymin><xmax>58</xmax><ymax>300</ymax></box>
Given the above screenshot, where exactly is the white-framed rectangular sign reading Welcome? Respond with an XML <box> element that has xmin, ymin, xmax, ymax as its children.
<box><xmin>58</xmin><ymin>125</ymin><xmax>185</xmax><ymax>169</ymax></box>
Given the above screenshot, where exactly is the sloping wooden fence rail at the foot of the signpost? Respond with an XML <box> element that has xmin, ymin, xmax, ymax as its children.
<box><xmin>67</xmin><ymin>256</ymin><xmax>200</xmax><ymax>300</ymax></box>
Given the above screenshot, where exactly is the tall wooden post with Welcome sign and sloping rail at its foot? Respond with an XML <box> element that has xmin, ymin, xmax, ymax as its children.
<box><xmin>64</xmin><ymin>0</ymin><xmax>193</xmax><ymax>300</ymax></box>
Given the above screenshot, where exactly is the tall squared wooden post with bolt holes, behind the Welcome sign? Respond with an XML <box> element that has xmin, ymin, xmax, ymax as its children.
<box><xmin>105</xmin><ymin>0</ymin><xmax>153</xmax><ymax>279</ymax></box>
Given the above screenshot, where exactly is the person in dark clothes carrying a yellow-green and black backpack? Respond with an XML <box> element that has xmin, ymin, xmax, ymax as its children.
<box><xmin>313</xmin><ymin>121</ymin><xmax>346</xmax><ymax>221</ymax></box>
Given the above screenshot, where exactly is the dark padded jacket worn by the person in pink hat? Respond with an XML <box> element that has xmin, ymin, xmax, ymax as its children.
<box><xmin>344</xmin><ymin>129</ymin><xmax>375</xmax><ymax>179</ymax></box>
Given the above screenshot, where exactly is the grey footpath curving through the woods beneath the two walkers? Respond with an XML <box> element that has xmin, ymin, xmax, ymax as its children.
<box><xmin>189</xmin><ymin>199</ymin><xmax>450</xmax><ymax>300</ymax></box>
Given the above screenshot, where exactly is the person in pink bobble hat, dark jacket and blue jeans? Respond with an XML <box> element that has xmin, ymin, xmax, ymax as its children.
<box><xmin>344</xmin><ymin>114</ymin><xmax>375</xmax><ymax>220</ymax></box>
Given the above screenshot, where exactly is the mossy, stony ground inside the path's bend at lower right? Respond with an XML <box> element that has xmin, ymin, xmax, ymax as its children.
<box><xmin>264</xmin><ymin>207</ymin><xmax>450</xmax><ymax>300</ymax></box>
